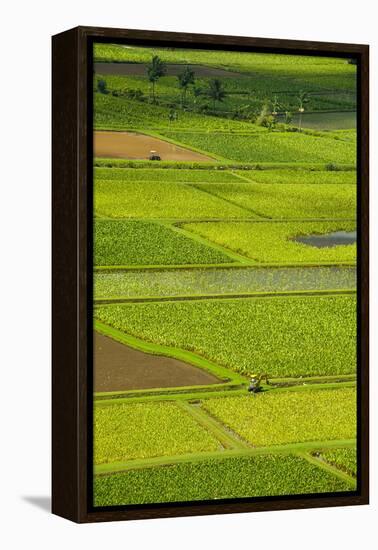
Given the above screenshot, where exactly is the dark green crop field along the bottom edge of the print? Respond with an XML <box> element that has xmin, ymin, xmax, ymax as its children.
<box><xmin>95</xmin><ymin>455</ymin><xmax>350</xmax><ymax>506</ymax></box>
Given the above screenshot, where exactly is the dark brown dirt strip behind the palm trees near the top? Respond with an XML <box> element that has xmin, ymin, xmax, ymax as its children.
<box><xmin>94</xmin><ymin>62</ymin><xmax>245</xmax><ymax>78</ymax></box>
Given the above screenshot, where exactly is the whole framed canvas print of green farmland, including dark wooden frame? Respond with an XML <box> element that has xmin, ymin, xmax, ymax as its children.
<box><xmin>52</xmin><ymin>27</ymin><xmax>369</xmax><ymax>522</ymax></box>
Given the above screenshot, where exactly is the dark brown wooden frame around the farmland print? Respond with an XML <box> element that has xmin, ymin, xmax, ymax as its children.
<box><xmin>52</xmin><ymin>27</ymin><xmax>369</xmax><ymax>523</ymax></box>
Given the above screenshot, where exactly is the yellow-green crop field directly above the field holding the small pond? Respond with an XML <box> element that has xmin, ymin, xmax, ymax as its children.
<box><xmin>198</xmin><ymin>183</ymin><xmax>356</xmax><ymax>218</ymax></box>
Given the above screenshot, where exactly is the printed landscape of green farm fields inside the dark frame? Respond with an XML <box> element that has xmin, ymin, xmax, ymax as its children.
<box><xmin>93</xmin><ymin>44</ymin><xmax>358</xmax><ymax>507</ymax></box>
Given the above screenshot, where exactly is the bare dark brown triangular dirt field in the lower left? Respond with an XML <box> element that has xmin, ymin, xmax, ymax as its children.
<box><xmin>93</xmin><ymin>332</ymin><xmax>221</xmax><ymax>392</ymax></box>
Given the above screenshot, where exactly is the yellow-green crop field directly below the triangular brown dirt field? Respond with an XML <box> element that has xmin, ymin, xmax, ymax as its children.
<box><xmin>94</xmin><ymin>402</ymin><xmax>220</xmax><ymax>464</ymax></box>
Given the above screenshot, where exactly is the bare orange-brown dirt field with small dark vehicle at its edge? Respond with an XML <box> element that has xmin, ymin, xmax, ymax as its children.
<box><xmin>94</xmin><ymin>131</ymin><xmax>214</xmax><ymax>161</ymax></box>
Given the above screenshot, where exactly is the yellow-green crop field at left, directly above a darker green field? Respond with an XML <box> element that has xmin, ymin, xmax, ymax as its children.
<box><xmin>94</xmin><ymin>179</ymin><xmax>251</xmax><ymax>220</ymax></box>
